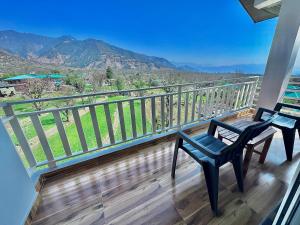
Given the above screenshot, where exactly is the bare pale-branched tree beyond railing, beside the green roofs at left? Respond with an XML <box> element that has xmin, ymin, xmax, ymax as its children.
<box><xmin>23</xmin><ymin>79</ymin><xmax>54</xmax><ymax>111</ymax></box>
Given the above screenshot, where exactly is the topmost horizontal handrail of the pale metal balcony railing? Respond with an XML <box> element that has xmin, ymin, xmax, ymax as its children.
<box><xmin>0</xmin><ymin>76</ymin><xmax>259</xmax><ymax>107</ymax></box>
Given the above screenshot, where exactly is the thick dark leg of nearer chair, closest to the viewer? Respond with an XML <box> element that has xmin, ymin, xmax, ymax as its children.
<box><xmin>202</xmin><ymin>163</ymin><xmax>219</xmax><ymax>216</ymax></box>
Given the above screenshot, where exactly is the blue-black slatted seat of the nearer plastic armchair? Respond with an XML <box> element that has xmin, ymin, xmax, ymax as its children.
<box><xmin>183</xmin><ymin>134</ymin><xmax>227</xmax><ymax>160</ymax></box>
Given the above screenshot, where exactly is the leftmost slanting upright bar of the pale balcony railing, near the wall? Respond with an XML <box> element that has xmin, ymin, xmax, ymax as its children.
<box><xmin>3</xmin><ymin>105</ymin><xmax>36</xmax><ymax>168</ymax></box>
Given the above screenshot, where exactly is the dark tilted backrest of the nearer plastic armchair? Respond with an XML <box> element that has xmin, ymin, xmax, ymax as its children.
<box><xmin>222</xmin><ymin>114</ymin><xmax>277</xmax><ymax>163</ymax></box>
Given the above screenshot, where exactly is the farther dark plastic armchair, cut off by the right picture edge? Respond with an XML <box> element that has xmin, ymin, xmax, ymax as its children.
<box><xmin>254</xmin><ymin>103</ymin><xmax>300</xmax><ymax>161</ymax></box>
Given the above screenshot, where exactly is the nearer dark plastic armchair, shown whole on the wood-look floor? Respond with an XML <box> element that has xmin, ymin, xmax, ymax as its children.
<box><xmin>172</xmin><ymin>117</ymin><xmax>273</xmax><ymax>215</ymax></box>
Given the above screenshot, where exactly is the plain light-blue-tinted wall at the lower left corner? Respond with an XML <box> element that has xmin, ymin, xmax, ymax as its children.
<box><xmin>0</xmin><ymin>120</ymin><xmax>37</xmax><ymax>225</ymax></box>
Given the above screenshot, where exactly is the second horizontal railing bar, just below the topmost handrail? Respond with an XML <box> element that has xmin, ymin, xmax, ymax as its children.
<box><xmin>8</xmin><ymin>81</ymin><xmax>255</xmax><ymax>117</ymax></box>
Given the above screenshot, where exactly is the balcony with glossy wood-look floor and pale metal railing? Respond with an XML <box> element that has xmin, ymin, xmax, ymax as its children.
<box><xmin>1</xmin><ymin>77</ymin><xmax>300</xmax><ymax>224</ymax></box>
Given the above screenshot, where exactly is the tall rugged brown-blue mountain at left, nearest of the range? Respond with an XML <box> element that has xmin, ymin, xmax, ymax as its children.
<box><xmin>0</xmin><ymin>30</ymin><xmax>175</xmax><ymax>72</ymax></box>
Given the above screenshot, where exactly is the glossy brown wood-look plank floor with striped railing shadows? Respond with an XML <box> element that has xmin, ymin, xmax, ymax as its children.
<box><xmin>33</xmin><ymin>125</ymin><xmax>300</xmax><ymax>225</ymax></box>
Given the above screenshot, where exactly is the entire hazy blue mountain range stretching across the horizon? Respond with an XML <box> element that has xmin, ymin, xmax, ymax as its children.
<box><xmin>0</xmin><ymin>30</ymin><xmax>300</xmax><ymax>75</ymax></box>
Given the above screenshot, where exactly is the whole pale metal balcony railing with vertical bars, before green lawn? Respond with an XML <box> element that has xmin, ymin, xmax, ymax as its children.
<box><xmin>1</xmin><ymin>77</ymin><xmax>259</xmax><ymax>169</ymax></box>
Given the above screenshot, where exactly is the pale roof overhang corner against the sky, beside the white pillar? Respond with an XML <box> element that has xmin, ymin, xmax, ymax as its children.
<box><xmin>240</xmin><ymin>0</ymin><xmax>281</xmax><ymax>23</ymax></box>
